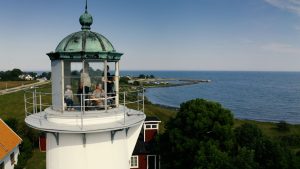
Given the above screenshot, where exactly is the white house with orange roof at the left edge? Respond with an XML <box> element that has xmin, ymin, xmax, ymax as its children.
<box><xmin>0</xmin><ymin>119</ymin><xmax>22</xmax><ymax>169</ymax></box>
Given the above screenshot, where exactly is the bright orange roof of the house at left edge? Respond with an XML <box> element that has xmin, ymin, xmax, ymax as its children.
<box><xmin>0</xmin><ymin>119</ymin><xmax>22</xmax><ymax>159</ymax></box>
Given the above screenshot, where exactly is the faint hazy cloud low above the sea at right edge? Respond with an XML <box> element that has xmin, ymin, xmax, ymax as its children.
<box><xmin>261</xmin><ymin>43</ymin><xmax>300</xmax><ymax>55</ymax></box>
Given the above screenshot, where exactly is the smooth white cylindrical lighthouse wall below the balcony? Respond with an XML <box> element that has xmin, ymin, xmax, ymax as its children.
<box><xmin>46</xmin><ymin>123</ymin><xmax>142</xmax><ymax>169</ymax></box>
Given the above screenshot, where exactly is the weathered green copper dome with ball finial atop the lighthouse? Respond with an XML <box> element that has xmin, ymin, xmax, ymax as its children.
<box><xmin>47</xmin><ymin>3</ymin><xmax>122</xmax><ymax>61</ymax></box>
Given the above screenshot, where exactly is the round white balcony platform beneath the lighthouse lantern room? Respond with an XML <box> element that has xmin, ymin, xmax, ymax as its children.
<box><xmin>25</xmin><ymin>106</ymin><xmax>146</xmax><ymax>133</ymax></box>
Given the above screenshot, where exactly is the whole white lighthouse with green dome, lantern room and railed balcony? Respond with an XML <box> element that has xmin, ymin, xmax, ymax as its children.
<box><xmin>24</xmin><ymin>1</ymin><xmax>146</xmax><ymax>169</ymax></box>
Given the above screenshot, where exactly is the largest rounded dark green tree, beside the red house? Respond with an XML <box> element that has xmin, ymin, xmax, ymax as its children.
<box><xmin>159</xmin><ymin>99</ymin><xmax>233</xmax><ymax>169</ymax></box>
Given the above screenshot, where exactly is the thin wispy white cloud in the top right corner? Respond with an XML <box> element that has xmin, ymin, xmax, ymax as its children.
<box><xmin>265</xmin><ymin>0</ymin><xmax>300</xmax><ymax>15</ymax></box>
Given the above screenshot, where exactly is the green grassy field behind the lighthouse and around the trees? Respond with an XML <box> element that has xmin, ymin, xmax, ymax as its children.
<box><xmin>0</xmin><ymin>84</ymin><xmax>300</xmax><ymax>169</ymax></box>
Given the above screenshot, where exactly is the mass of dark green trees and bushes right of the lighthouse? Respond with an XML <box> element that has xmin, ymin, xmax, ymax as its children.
<box><xmin>158</xmin><ymin>99</ymin><xmax>300</xmax><ymax>169</ymax></box>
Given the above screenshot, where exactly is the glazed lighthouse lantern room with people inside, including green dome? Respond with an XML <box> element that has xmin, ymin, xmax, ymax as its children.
<box><xmin>47</xmin><ymin>5</ymin><xmax>122</xmax><ymax>111</ymax></box>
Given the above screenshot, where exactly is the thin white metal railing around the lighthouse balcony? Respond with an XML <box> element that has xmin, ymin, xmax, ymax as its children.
<box><xmin>24</xmin><ymin>88</ymin><xmax>145</xmax><ymax>116</ymax></box>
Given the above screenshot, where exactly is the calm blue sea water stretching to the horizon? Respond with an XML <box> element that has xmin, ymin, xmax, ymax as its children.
<box><xmin>122</xmin><ymin>71</ymin><xmax>300</xmax><ymax>124</ymax></box>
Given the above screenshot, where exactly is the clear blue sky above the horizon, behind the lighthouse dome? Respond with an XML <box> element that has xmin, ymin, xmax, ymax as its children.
<box><xmin>0</xmin><ymin>0</ymin><xmax>300</xmax><ymax>71</ymax></box>
